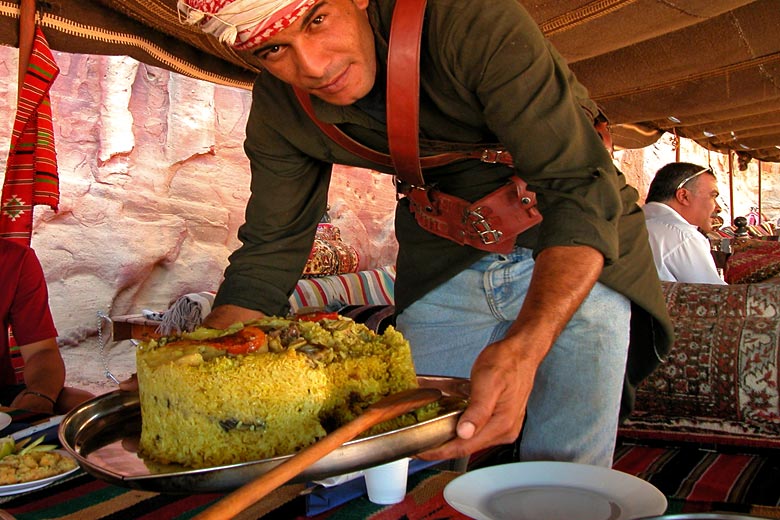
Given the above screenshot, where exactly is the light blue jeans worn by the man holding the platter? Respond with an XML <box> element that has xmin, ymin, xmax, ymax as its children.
<box><xmin>398</xmin><ymin>248</ymin><xmax>631</xmax><ymax>467</ymax></box>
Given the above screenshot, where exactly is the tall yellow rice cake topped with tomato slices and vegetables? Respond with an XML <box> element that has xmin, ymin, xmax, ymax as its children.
<box><xmin>136</xmin><ymin>316</ymin><xmax>436</xmax><ymax>468</ymax></box>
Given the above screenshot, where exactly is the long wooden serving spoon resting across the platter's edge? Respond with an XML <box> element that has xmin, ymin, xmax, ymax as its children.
<box><xmin>193</xmin><ymin>388</ymin><xmax>441</xmax><ymax>520</ymax></box>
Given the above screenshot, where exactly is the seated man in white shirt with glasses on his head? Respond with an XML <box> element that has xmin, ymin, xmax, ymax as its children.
<box><xmin>643</xmin><ymin>162</ymin><xmax>726</xmax><ymax>284</ymax></box>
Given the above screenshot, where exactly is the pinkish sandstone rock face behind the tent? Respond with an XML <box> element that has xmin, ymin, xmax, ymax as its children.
<box><xmin>0</xmin><ymin>47</ymin><xmax>780</xmax><ymax>390</ymax></box>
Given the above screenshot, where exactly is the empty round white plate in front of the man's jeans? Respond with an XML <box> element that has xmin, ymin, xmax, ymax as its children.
<box><xmin>444</xmin><ymin>462</ymin><xmax>666</xmax><ymax>520</ymax></box>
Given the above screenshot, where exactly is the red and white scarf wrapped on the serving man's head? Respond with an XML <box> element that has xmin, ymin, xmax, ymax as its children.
<box><xmin>177</xmin><ymin>0</ymin><xmax>317</xmax><ymax>50</ymax></box>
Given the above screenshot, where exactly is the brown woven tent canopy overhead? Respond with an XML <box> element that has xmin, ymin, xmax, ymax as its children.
<box><xmin>0</xmin><ymin>0</ymin><xmax>780</xmax><ymax>162</ymax></box>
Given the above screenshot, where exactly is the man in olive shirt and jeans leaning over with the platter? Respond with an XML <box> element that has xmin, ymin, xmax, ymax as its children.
<box><xmin>149</xmin><ymin>0</ymin><xmax>672</xmax><ymax>466</ymax></box>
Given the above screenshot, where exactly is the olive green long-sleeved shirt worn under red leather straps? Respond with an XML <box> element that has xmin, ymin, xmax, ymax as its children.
<box><xmin>216</xmin><ymin>0</ymin><xmax>672</xmax><ymax>412</ymax></box>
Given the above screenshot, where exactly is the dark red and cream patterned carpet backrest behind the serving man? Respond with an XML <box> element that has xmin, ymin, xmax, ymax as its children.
<box><xmin>621</xmin><ymin>282</ymin><xmax>780</xmax><ymax>449</ymax></box>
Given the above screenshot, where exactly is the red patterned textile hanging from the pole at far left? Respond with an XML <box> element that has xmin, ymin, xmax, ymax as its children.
<box><xmin>0</xmin><ymin>27</ymin><xmax>59</xmax><ymax>245</ymax></box>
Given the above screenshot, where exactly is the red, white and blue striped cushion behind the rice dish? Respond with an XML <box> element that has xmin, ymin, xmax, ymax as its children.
<box><xmin>290</xmin><ymin>266</ymin><xmax>395</xmax><ymax>312</ymax></box>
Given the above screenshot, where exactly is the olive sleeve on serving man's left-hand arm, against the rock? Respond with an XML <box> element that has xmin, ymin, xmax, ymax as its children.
<box><xmin>215</xmin><ymin>83</ymin><xmax>332</xmax><ymax>315</ymax></box>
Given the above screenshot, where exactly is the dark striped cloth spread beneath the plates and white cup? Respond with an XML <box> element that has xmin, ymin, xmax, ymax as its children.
<box><xmin>0</xmin><ymin>444</ymin><xmax>780</xmax><ymax>520</ymax></box>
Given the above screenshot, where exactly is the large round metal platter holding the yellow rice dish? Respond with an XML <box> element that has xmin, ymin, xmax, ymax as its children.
<box><xmin>59</xmin><ymin>376</ymin><xmax>469</xmax><ymax>493</ymax></box>
